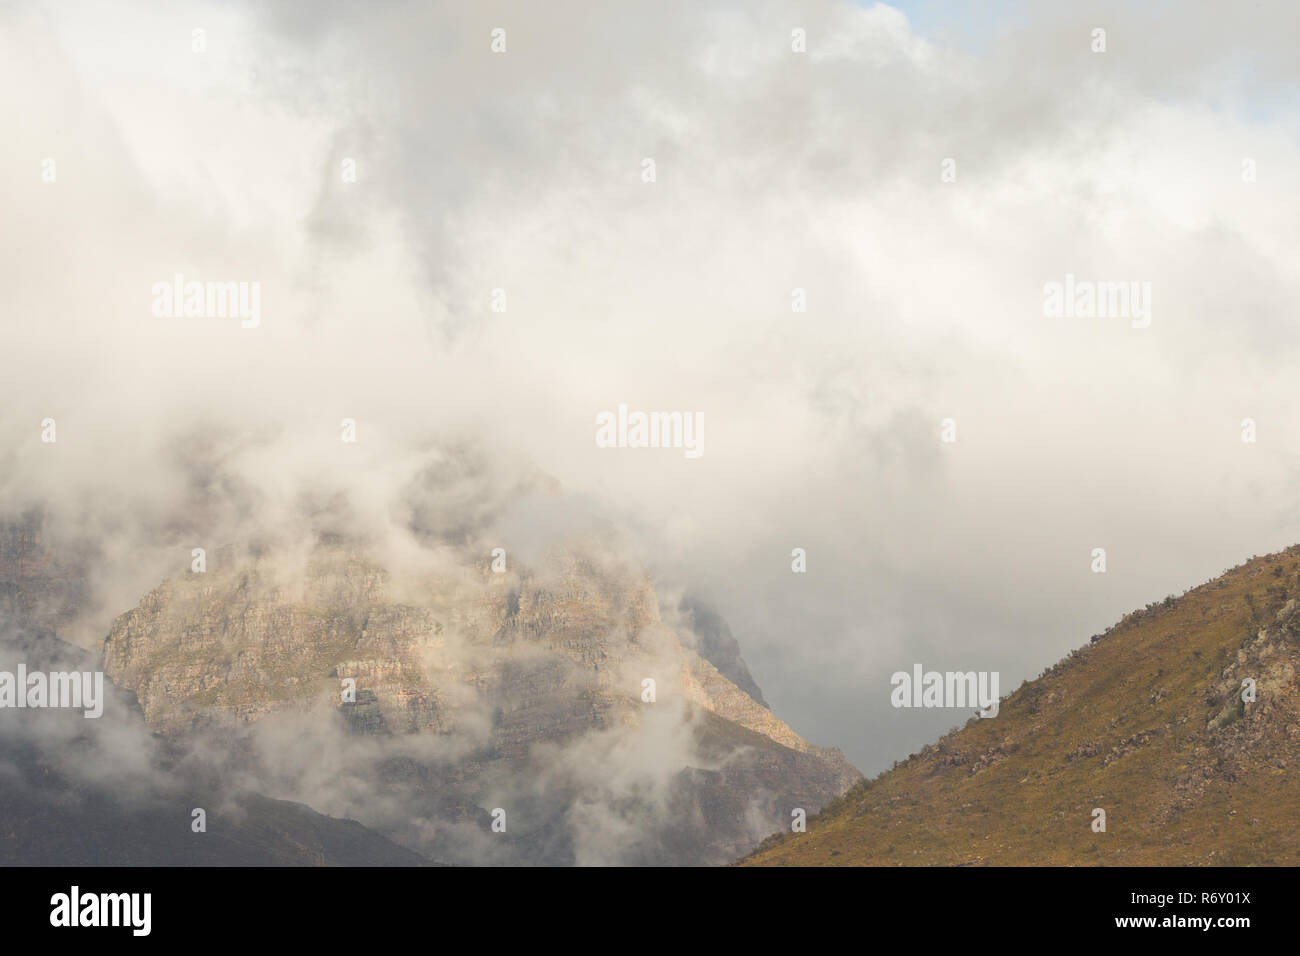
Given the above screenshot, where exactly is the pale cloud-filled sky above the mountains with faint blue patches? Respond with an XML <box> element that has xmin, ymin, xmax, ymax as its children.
<box><xmin>0</xmin><ymin>0</ymin><xmax>1300</xmax><ymax>774</ymax></box>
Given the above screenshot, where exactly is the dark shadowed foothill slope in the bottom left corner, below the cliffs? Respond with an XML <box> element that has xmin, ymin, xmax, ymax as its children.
<box><xmin>0</xmin><ymin>626</ymin><xmax>430</xmax><ymax>866</ymax></box>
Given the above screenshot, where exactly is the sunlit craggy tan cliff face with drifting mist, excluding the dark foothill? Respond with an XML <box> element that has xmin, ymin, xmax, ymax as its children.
<box><xmin>104</xmin><ymin>549</ymin><xmax>859</xmax><ymax>864</ymax></box>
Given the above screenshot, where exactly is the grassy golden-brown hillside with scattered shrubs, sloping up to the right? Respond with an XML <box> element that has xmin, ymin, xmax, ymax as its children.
<box><xmin>742</xmin><ymin>548</ymin><xmax>1300</xmax><ymax>866</ymax></box>
